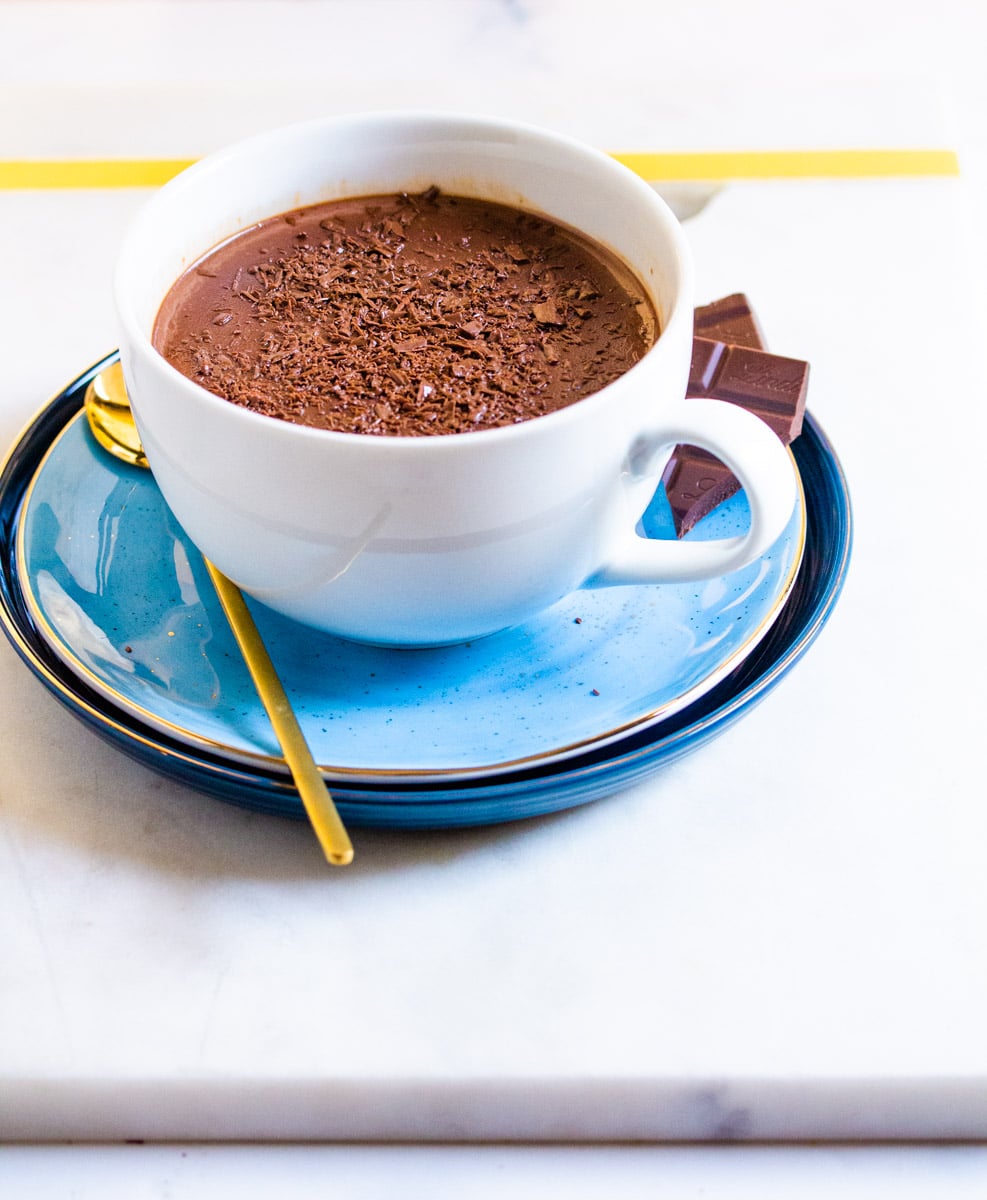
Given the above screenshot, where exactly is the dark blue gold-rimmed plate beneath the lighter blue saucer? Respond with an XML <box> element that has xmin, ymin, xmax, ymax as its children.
<box><xmin>0</xmin><ymin>355</ymin><xmax>851</xmax><ymax>828</ymax></box>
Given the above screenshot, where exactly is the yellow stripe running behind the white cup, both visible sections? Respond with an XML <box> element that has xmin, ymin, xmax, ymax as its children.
<box><xmin>0</xmin><ymin>150</ymin><xmax>959</xmax><ymax>190</ymax></box>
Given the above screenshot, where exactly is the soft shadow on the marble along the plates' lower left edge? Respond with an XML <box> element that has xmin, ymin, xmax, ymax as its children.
<box><xmin>0</xmin><ymin>649</ymin><xmax>633</xmax><ymax>887</ymax></box>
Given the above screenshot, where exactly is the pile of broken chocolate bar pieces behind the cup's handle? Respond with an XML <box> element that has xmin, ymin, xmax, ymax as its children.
<box><xmin>662</xmin><ymin>294</ymin><xmax>809</xmax><ymax>538</ymax></box>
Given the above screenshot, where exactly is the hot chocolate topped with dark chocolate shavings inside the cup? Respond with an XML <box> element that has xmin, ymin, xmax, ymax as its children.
<box><xmin>154</xmin><ymin>188</ymin><xmax>658</xmax><ymax>434</ymax></box>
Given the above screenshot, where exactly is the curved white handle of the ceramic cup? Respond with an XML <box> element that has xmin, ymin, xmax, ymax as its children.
<box><xmin>585</xmin><ymin>397</ymin><xmax>797</xmax><ymax>587</ymax></box>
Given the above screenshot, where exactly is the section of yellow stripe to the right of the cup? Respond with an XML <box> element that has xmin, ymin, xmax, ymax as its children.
<box><xmin>614</xmin><ymin>150</ymin><xmax>959</xmax><ymax>181</ymax></box>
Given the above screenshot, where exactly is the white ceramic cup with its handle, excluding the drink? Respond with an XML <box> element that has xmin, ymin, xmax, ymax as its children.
<box><xmin>115</xmin><ymin>113</ymin><xmax>796</xmax><ymax>646</ymax></box>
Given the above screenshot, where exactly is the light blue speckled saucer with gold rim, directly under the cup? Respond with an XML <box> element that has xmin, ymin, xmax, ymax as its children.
<box><xmin>17</xmin><ymin>403</ymin><xmax>806</xmax><ymax>781</ymax></box>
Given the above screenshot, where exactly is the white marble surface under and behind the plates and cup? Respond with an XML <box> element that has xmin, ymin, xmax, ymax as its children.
<box><xmin>0</xmin><ymin>0</ymin><xmax>987</xmax><ymax>1171</ymax></box>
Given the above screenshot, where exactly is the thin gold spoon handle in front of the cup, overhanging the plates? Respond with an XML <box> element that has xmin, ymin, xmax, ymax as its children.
<box><xmin>205</xmin><ymin>559</ymin><xmax>353</xmax><ymax>866</ymax></box>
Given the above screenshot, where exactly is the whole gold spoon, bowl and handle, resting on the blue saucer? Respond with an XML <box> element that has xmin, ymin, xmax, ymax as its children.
<box><xmin>85</xmin><ymin>362</ymin><xmax>353</xmax><ymax>866</ymax></box>
